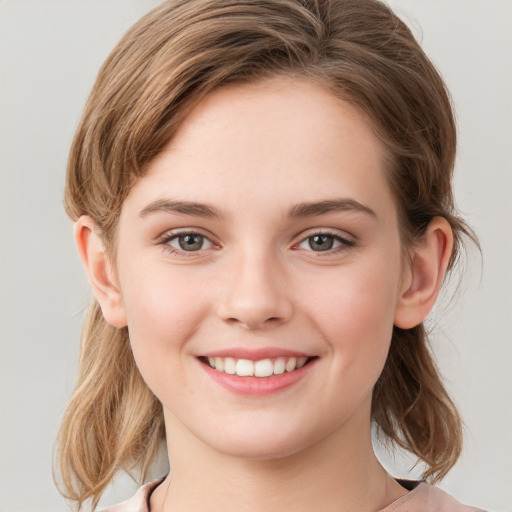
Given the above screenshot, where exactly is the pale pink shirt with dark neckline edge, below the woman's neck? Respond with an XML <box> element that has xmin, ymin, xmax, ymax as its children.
<box><xmin>103</xmin><ymin>477</ymin><xmax>484</xmax><ymax>512</ymax></box>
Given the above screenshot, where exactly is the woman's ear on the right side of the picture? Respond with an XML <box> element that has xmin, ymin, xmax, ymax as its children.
<box><xmin>394</xmin><ymin>217</ymin><xmax>453</xmax><ymax>329</ymax></box>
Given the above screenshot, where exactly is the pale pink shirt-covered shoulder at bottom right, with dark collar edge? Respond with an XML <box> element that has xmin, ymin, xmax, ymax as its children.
<box><xmin>381</xmin><ymin>481</ymin><xmax>484</xmax><ymax>512</ymax></box>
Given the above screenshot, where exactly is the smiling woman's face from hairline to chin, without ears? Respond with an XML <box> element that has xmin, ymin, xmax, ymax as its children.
<box><xmin>116</xmin><ymin>79</ymin><xmax>403</xmax><ymax>458</ymax></box>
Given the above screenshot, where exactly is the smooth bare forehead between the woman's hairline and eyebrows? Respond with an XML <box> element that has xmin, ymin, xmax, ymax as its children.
<box><xmin>122</xmin><ymin>78</ymin><xmax>391</xmax><ymax>220</ymax></box>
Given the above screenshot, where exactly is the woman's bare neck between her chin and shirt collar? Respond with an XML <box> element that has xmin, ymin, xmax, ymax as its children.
<box><xmin>151</xmin><ymin>404</ymin><xmax>405</xmax><ymax>512</ymax></box>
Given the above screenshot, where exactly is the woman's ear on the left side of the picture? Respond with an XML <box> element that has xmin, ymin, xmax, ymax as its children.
<box><xmin>75</xmin><ymin>215</ymin><xmax>126</xmax><ymax>328</ymax></box>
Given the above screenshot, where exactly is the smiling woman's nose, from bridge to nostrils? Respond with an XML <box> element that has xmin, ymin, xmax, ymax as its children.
<box><xmin>218</xmin><ymin>249</ymin><xmax>293</xmax><ymax>330</ymax></box>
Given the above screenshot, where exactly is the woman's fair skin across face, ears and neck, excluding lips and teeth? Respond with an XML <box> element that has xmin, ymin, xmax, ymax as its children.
<box><xmin>76</xmin><ymin>78</ymin><xmax>452</xmax><ymax>512</ymax></box>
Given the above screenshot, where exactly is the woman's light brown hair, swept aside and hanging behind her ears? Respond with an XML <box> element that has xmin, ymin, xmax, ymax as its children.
<box><xmin>59</xmin><ymin>0</ymin><xmax>472</xmax><ymax>506</ymax></box>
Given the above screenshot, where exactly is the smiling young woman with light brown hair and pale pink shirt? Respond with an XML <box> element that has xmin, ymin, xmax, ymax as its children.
<box><xmin>55</xmin><ymin>0</ymin><xmax>484</xmax><ymax>512</ymax></box>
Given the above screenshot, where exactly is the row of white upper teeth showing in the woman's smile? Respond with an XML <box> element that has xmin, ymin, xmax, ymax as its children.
<box><xmin>208</xmin><ymin>357</ymin><xmax>308</xmax><ymax>377</ymax></box>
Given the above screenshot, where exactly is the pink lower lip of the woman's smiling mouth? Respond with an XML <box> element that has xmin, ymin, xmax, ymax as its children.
<box><xmin>200</xmin><ymin>359</ymin><xmax>316</xmax><ymax>396</ymax></box>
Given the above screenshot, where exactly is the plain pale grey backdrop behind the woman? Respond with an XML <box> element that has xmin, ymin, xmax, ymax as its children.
<box><xmin>0</xmin><ymin>0</ymin><xmax>512</xmax><ymax>512</ymax></box>
